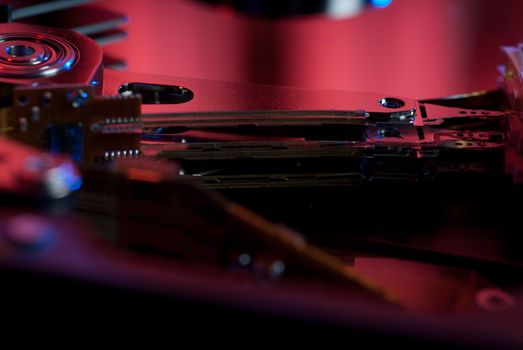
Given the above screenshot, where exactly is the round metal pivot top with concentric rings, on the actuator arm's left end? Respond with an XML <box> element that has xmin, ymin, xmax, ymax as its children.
<box><xmin>0</xmin><ymin>33</ymin><xmax>80</xmax><ymax>78</ymax></box>
